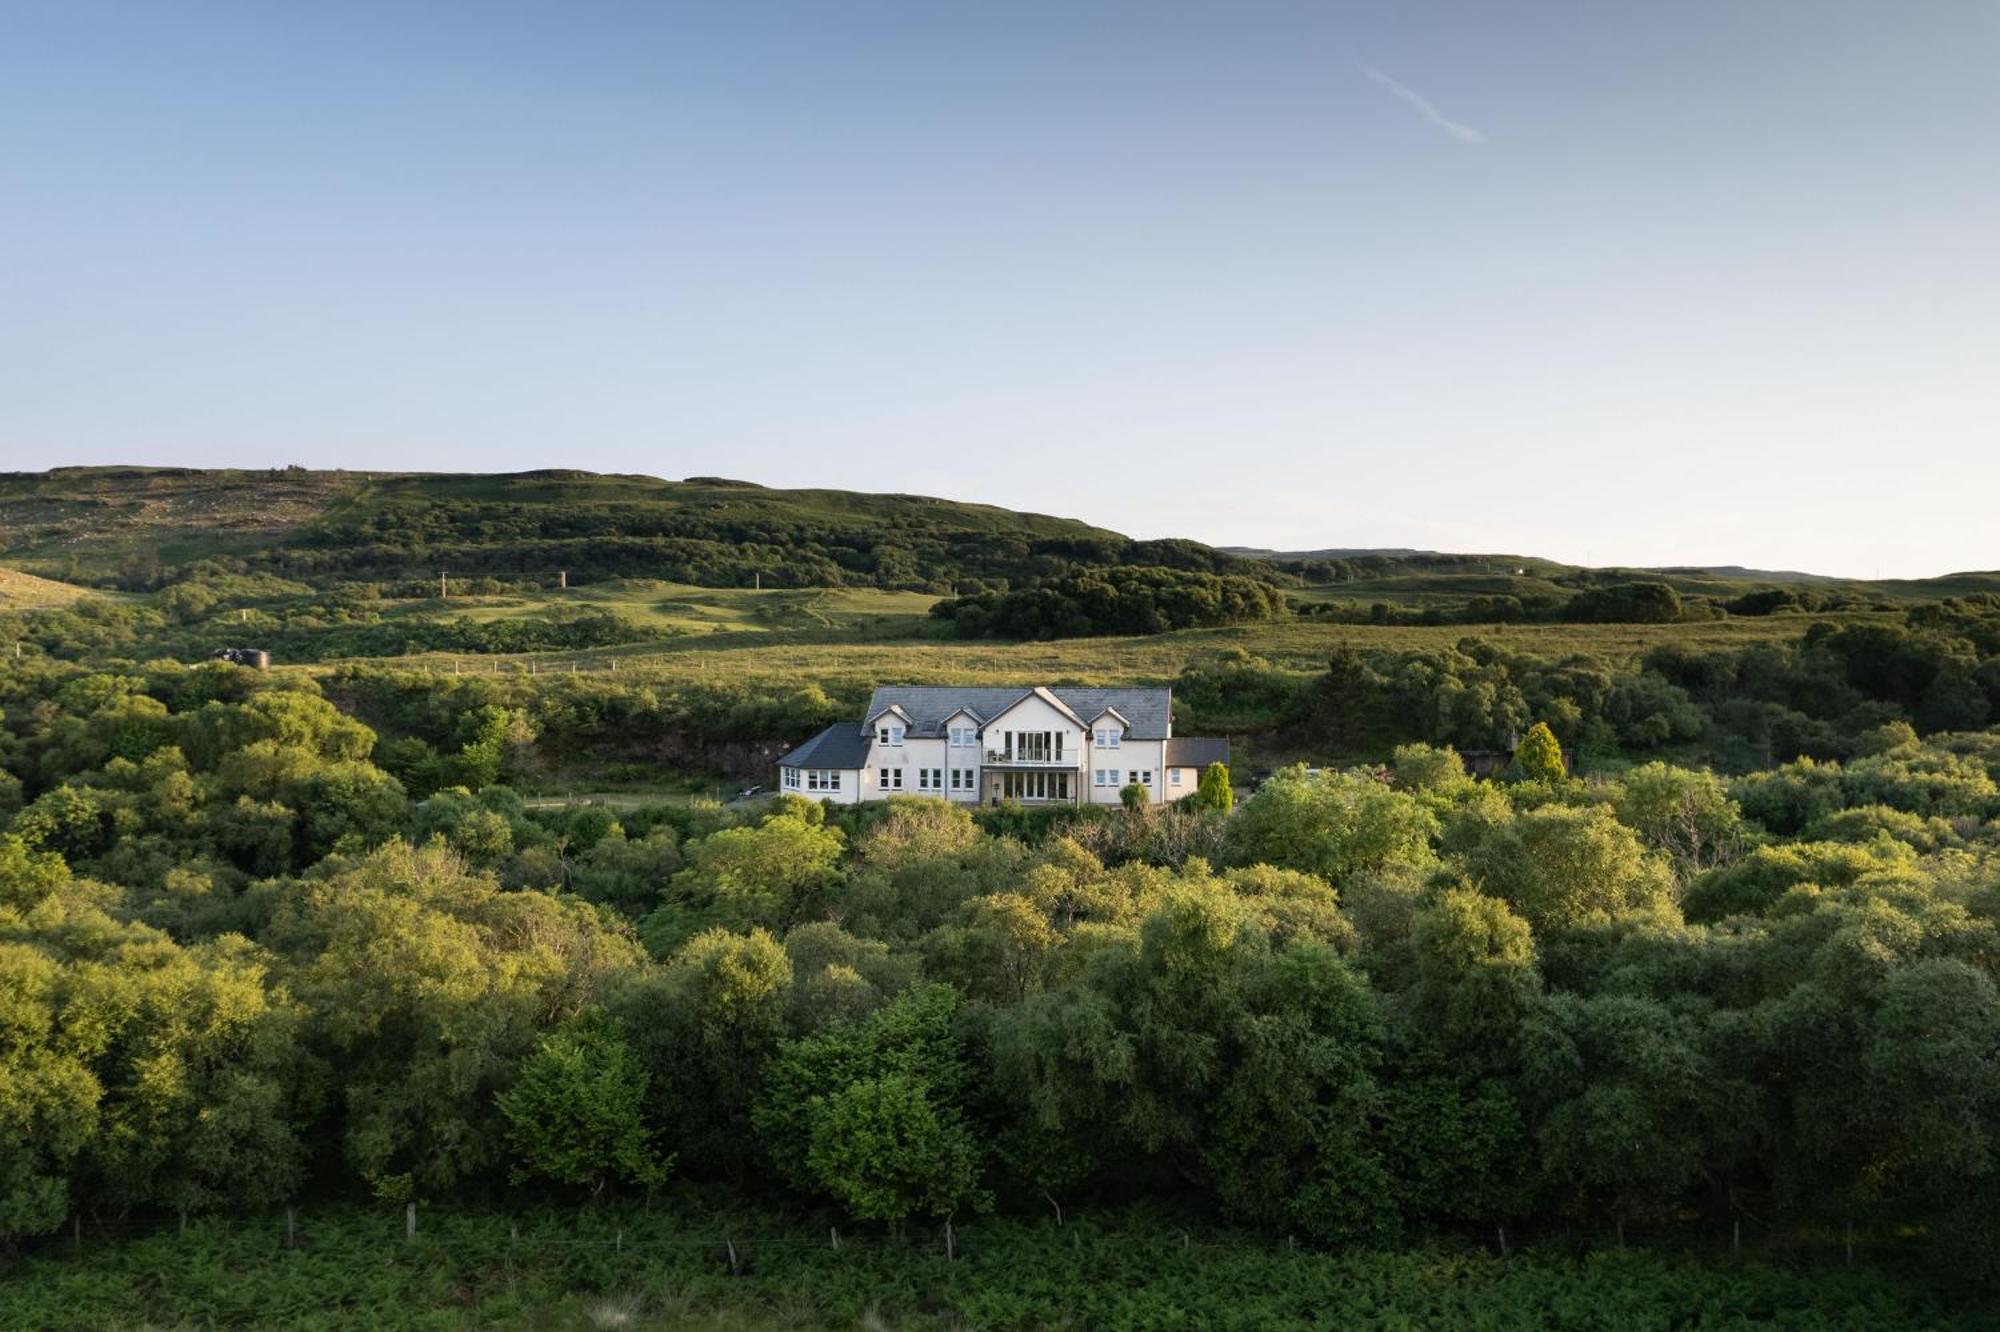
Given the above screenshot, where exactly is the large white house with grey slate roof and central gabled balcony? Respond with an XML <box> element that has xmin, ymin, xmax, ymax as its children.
<box><xmin>778</xmin><ymin>684</ymin><xmax>1230</xmax><ymax>804</ymax></box>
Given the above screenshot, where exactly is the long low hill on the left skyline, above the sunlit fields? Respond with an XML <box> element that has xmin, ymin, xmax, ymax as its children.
<box><xmin>0</xmin><ymin>468</ymin><xmax>1244</xmax><ymax>594</ymax></box>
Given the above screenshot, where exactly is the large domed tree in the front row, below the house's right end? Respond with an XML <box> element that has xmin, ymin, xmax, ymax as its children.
<box><xmin>994</xmin><ymin>880</ymin><xmax>1394</xmax><ymax>1238</ymax></box>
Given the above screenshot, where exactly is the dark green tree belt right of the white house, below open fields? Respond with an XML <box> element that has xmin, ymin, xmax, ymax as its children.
<box><xmin>1174</xmin><ymin>598</ymin><xmax>2000</xmax><ymax>772</ymax></box>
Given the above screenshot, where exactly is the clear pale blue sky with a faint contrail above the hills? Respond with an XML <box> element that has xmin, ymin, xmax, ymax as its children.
<box><xmin>0</xmin><ymin>0</ymin><xmax>2000</xmax><ymax>576</ymax></box>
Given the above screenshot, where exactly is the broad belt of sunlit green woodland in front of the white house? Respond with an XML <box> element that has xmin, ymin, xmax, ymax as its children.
<box><xmin>0</xmin><ymin>666</ymin><xmax>2000</xmax><ymax>1280</ymax></box>
